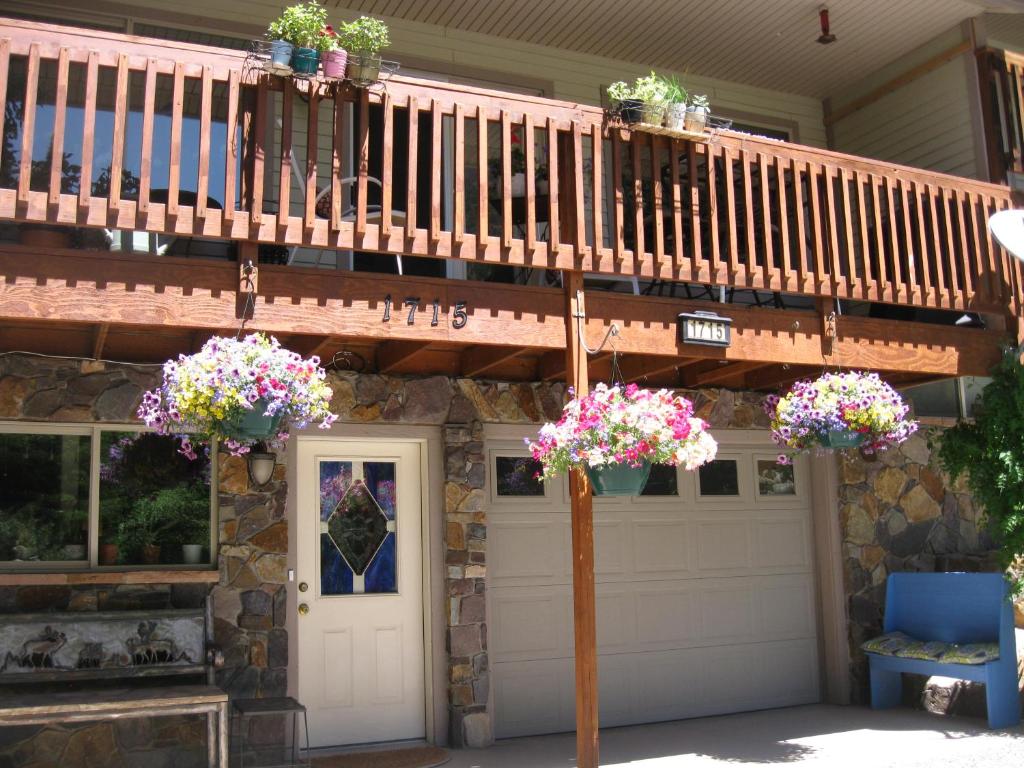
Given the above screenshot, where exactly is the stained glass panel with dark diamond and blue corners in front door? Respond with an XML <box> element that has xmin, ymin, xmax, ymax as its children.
<box><xmin>318</xmin><ymin>460</ymin><xmax>398</xmax><ymax>596</ymax></box>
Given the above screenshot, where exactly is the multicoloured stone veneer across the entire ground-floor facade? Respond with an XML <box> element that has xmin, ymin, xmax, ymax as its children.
<box><xmin>0</xmin><ymin>356</ymin><xmax>1003</xmax><ymax>753</ymax></box>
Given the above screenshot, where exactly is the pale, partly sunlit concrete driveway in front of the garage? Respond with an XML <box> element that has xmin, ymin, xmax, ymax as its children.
<box><xmin>445</xmin><ymin>705</ymin><xmax>1024</xmax><ymax>768</ymax></box>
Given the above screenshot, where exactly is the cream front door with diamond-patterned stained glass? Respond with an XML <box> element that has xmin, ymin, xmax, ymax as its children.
<box><xmin>296</xmin><ymin>437</ymin><xmax>426</xmax><ymax>746</ymax></box>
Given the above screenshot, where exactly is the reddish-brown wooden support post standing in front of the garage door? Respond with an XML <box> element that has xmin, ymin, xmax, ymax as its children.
<box><xmin>562</xmin><ymin>272</ymin><xmax>598</xmax><ymax>768</ymax></box>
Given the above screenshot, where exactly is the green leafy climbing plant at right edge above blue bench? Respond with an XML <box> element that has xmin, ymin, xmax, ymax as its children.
<box><xmin>939</xmin><ymin>347</ymin><xmax>1024</xmax><ymax>595</ymax></box>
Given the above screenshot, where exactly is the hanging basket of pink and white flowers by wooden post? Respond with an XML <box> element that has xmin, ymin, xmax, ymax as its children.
<box><xmin>527</xmin><ymin>384</ymin><xmax>718</xmax><ymax>496</ymax></box>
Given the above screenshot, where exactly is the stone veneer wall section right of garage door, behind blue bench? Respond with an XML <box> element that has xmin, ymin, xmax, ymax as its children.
<box><xmin>839</xmin><ymin>429</ymin><xmax>997</xmax><ymax>703</ymax></box>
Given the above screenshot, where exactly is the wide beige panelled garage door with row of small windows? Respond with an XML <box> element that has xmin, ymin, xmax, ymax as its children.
<box><xmin>487</xmin><ymin>430</ymin><xmax>819</xmax><ymax>737</ymax></box>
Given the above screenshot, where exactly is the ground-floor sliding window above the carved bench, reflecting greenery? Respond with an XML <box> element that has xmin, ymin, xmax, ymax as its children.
<box><xmin>0</xmin><ymin>423</ymin><xmax>216</xmax><ymax>569</ymax></box>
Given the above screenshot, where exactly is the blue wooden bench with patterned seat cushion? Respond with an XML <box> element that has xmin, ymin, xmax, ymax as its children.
<box><xmin>861</xmin><ymin>573</ymin><xmax>1021</xmax><ymax>728</ymax></box>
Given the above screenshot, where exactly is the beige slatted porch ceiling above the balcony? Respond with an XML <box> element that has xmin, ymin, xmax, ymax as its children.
<box><xmin>342</xmin><ymin>0</ymin><xmax>1024</xmax><ymax>98</ymax></box>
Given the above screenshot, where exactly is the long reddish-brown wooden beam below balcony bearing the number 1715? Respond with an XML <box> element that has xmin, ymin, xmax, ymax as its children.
<box><xmin>0</xmin><ymin>250</ymin><xmax>1005</xmax><ymax>380</ymax></box>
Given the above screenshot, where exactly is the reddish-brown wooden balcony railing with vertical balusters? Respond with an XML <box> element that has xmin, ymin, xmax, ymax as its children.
<box><xmin>0</xmin><ymin>19</ymin><xmax>1020</xmax><ymax>319</ymax></box>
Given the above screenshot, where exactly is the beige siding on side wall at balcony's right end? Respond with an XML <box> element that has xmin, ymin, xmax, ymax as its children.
<box><xmin>833</xmin><ymin>23</ymin><xmax>984</xmax><ymax>178</ymax></box>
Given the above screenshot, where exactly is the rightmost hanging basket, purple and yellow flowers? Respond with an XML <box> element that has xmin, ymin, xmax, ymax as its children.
<box><xmin>764</xmin><ymin>371</ymin><xmax>918</xmax><ymax>464</ymax></box>
